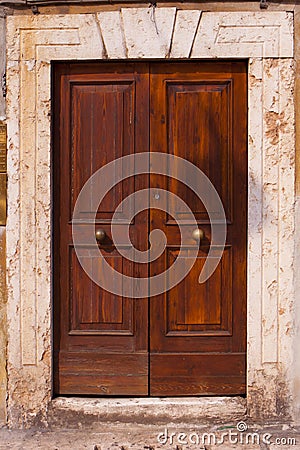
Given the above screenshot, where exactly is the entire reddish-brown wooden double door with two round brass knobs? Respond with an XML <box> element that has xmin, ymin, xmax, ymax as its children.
<box><xmin>53</xmin><ymin>61</ymin><xmax>247</xmax><ymax>396</ymax></box>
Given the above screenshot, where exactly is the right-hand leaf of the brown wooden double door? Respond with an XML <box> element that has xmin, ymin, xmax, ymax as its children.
<box><xmin>150</xmin><ymin>62</ymin><xmax>247</xmax><ymax>396</ymax></box>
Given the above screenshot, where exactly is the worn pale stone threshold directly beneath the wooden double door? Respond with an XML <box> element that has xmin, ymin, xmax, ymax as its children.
<box><xmin>47</xmin><ymin>396</ymin><xmax>247</xmax><ymax>428</ymax></box>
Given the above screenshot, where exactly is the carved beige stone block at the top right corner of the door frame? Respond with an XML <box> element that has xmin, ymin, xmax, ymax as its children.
<box><xmin>192</xmin><ymin>11</ymin><xmax>293</xmax><ymax>58</ymax></box>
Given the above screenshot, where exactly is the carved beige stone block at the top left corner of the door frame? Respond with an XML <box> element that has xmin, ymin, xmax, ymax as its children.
<box><xmin>7</xmin><ymin>14</ymin><xmax>104</xmax><ymax>64</ymax></box>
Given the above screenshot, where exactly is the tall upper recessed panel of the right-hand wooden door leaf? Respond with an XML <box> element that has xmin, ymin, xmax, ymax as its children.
<box><xmin>166</xmin><ymin>80</ymin><xmax>233</xmax><ymax>223</ymax></box>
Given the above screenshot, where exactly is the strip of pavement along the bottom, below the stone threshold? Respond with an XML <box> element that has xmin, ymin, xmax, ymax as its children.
<box><xmin>0</xmin><ymin>423</ymin><xmax>300</xmax><ymax>450</ymax></box>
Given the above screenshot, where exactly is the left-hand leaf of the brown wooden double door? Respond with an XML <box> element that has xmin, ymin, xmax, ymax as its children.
<box><xmin>53</xmin><ymin>64</ymin><xmax>149</xmax><ymax>395</ymax></box>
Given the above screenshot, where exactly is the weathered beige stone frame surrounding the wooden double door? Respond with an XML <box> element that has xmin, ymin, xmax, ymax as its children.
<box><xmin>6</xmin><ymin>7</ymin><xmax>295</xmax><ymax>426</ymax></box>
